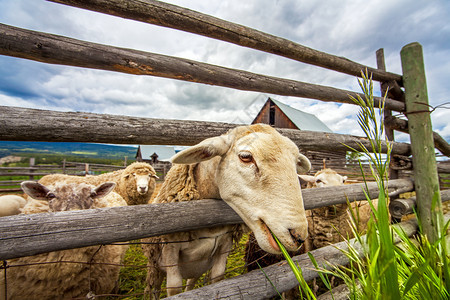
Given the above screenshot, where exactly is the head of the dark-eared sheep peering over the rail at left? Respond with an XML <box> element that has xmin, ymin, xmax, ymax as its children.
<box><xmin>21</xmin><ymin>181</ymin><xmax>116</xmax><ymax>212</ymax></box>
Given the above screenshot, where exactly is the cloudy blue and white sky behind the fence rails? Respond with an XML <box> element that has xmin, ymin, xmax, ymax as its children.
<box><xmin>0</xmin><ymin>0</ymin><xmax>450</xmax><ymax>145</ymax></box>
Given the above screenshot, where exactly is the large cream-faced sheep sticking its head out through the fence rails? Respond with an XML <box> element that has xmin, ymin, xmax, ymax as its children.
<box><xmin>143</xmin><ymin>125</ymin><xmax>311</xmax><ymax>298</ymax></box>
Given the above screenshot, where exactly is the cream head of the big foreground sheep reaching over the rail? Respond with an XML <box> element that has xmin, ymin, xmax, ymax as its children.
<box><xmin>172</xmin><ymin>124</ymin><xmax>311</xmax><ymax>253</ymax></box>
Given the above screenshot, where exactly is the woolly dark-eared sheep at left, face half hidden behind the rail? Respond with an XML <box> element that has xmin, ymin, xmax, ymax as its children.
<box><xmin>0</xmin><ymin>181</ymin><xmax>127</xmax><ymax>300</ymax></box>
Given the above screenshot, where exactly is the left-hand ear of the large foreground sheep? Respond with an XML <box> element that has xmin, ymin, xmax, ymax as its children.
<box><xmin>171</xmin><ymin>135</ymin><xmax>231</xmax><ymax>164</ymax></box>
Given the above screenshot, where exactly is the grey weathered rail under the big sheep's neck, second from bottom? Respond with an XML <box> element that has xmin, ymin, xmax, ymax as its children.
<box><xmin>0</xmin><ymin>179</ymin><xmax>413</xmax><ymax>260</ymax></box>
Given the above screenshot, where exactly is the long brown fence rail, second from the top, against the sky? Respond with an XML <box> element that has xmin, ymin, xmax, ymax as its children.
<box><xmin>0</xmin><ymin>24</ymin><xmax>405</xmax><ymax>111</ymax></box>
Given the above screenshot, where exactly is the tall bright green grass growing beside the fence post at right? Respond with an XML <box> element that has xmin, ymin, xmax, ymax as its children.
<box><xmin>272</xmin><ymin>74</ymin><xmax>450</xmax><ymax>300</ymax></box>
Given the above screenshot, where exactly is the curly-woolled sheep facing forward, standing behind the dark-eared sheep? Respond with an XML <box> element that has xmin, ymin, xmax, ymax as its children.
<box><xmin>39</xmin><ymin>162</ymin><xmax>158</xmax><ymax>205</ymax></box>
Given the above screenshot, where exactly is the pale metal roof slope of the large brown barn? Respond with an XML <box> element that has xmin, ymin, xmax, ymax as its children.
<box><xmin>268</xmin><ymin>98</ymin><xmax>333</xmax><ymax>133</ymax></box>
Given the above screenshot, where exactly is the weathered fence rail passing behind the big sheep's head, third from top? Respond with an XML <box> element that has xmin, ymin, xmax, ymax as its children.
<box><xmin>0</xmin><ymin>106</ymin><xmax>411</xmax><ymax>155</ymax></box>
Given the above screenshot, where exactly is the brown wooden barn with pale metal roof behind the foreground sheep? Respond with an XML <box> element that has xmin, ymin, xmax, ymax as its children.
<box><xmin>252</xmin><ymin>98</ymin><xmax>346</xmax><ymax>173</ymax></box>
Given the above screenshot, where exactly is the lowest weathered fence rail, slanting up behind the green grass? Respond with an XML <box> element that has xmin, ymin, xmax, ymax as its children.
<box><xmin>166</xmin><ymin>220</ymin><xmax>418</xmax><ymax>300</ymax></box>
